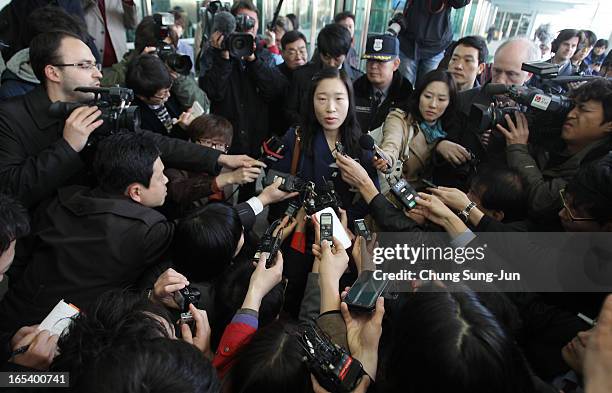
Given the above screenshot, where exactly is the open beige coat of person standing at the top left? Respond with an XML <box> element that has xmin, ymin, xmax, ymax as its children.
<box><xmin>81</xmin><ymin>0</ymin><xmax>139</xmax><ymax>61</ymax></box>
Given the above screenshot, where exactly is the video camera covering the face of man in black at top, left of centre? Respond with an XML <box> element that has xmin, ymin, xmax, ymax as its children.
<box><xmin>212</xmin><ymin>11</ymin><xmax>255</xmax><ymax>59</ymax></box>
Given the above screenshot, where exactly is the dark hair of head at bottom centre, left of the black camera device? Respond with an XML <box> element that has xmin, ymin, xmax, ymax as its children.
<box><xmin>224</xmin><ymin>321</ymin><xmax>312</xmax><ymax>393</ymax></box>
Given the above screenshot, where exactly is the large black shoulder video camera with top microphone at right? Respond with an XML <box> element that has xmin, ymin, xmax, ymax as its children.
<box><xmin>468</xmin><ymin>62</ymin><xmax>592</xmax><ymax>141</ymax></box>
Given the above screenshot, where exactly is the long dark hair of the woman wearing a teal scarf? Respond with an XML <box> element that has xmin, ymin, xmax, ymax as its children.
<box><xmin>408</xmin><ymin>70</ymin><xmax>457</xmax><ymax>130</ymax></box>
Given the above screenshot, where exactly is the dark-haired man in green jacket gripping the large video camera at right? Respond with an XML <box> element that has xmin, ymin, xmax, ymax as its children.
<box><xmin>497</xmin><ymin>78</ymin><xmax>612</xmax><ymax>227</ymax></box>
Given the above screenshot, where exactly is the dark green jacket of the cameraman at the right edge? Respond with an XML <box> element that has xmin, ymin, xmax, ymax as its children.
<box><xmin>506</xmin><ymin>138</ymin><xmax>610</xmax><ymax>218</ymax></box>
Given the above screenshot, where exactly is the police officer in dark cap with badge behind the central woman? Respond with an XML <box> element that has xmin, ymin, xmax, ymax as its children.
<box><xmin>353</xmin><ymin>34</ymin><xmax>412</xmax><ymax>132</ymax></box>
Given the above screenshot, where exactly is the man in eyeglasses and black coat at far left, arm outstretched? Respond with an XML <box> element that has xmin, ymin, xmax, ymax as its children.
<box><xmin>0</xmin><ymin>32</ymin><xmax>263</xmax><ymax>216</ymax></box>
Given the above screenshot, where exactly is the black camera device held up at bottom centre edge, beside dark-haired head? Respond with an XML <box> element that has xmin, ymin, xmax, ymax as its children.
<box><xmin>298</xmin><ymin>323</ymin><xmax>365</xmax><ymax>393</ymax></box>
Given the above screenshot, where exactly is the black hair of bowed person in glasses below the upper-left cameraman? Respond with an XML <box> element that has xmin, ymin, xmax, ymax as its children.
<box><xmin>125</xmin><ymin>54</ymin><xmax>172</xmax><ymax>98</ymax></box>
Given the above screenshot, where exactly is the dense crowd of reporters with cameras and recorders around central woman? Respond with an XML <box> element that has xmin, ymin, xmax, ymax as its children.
<box><xmin>0</xmin><ymin>0</ymin><xmax>612</xmax><ymax>393</ymax></box>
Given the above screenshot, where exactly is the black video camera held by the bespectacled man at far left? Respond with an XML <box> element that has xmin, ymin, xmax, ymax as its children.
<box><xmin>49</xmin><ymin>87</ymin><xmax>140</xmax><ymax>146</ymax></box>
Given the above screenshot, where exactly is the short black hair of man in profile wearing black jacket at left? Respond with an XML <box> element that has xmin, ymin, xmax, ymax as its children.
<box><xmin>93</xmin><ymin>132</ymin><xmax>160</xmax><ymax>195</ymax></box>
